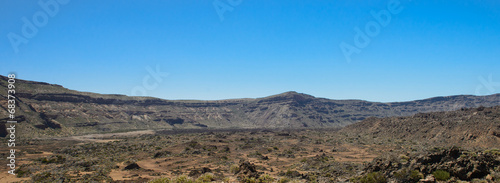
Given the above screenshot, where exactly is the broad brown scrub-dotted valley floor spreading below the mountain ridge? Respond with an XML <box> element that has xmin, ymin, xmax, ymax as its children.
<box><xmin>0</xmin><ymin>129</ymin><xmax>500</xmax><ymax>182</ymax></box>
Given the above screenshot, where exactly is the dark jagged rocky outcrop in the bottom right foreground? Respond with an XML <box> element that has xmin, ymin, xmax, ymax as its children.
<box><xmin>364</xmin><ymin>147</ymin><xmax>500</xmax><ymax>182</ymax></box>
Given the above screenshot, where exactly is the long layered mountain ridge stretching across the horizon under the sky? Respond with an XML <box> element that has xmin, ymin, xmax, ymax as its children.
<box><xmin>0</xmin><ymin>76</ymin><xmax>500</xmax><ymax>137</ymax></box>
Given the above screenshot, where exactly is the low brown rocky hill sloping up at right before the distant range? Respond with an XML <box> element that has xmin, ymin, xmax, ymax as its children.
<box><xmin>340</xmin><ymin>106</ymin><xmax>500</xmax><ymax>148</ymax></box>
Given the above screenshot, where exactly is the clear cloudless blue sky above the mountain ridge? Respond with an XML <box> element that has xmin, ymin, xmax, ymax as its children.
<box><xmin>0</xmin><ymin>0</ymin><xmax>500</xmax><ymax>102</ymax></box>
